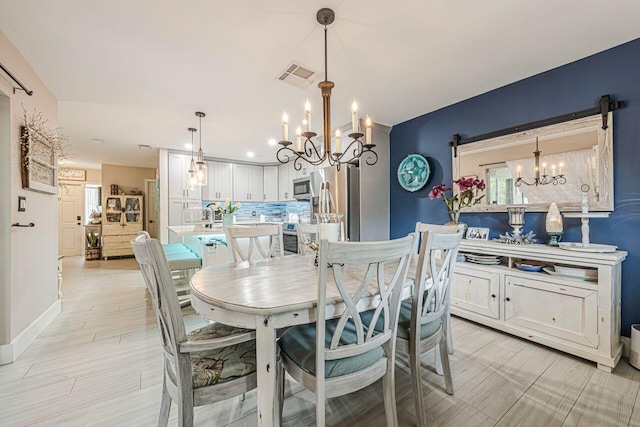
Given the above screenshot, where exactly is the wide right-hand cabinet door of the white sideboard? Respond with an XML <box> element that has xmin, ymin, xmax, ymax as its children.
<box><xmin>504</xmin><ymin>276</ymin><xmax>598</xmax><ymax>348</ymax></box>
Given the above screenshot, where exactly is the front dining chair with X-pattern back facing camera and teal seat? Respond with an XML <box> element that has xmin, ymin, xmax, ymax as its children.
<box><xmin>278</xmin><ymin>234</ymin><xmax>413</xmax><ymax>426</ymax></box>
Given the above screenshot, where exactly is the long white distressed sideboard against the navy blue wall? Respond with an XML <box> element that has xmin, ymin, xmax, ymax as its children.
<box><xmin>451</xmin><ymin>240</ymin><xmax>627</xmax><ymax>372</ymax></box>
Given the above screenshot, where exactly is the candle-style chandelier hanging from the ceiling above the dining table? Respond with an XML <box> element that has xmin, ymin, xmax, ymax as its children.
<box><xmin>276</xmin><ymin>8</ymin><xmax>378</xmax><ymax>170</ymax></box>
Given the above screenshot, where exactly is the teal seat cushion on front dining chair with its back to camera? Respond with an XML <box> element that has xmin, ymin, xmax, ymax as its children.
<box><xmin>278</xmin><ymin>319</ymin><xmax>384</xmax><ymax>378</ymax></box>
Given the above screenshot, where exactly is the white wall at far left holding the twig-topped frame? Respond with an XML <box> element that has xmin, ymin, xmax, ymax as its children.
<box><xmin>0</xmin><ymin>27</ymin><xmax>60</xmax><ymax>362</ymax></box>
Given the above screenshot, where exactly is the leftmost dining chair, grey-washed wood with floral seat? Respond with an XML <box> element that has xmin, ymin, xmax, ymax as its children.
<box><xmin>131</xmin><ymin>234</ymin><xmax>256</xmax><ymax>427</ymax></box>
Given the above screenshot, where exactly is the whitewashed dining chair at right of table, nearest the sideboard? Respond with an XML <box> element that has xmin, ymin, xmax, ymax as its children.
<box><xmin>398</xmin><ymin>230</ymin><xmax>462</xmax><ymax>427</ymax></box>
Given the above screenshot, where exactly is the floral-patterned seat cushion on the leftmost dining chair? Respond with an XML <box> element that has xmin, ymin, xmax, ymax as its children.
<box><xmin>187</xmin><ymin>323</ymin><xmax>256</xmax><ymax>388</ymax></box>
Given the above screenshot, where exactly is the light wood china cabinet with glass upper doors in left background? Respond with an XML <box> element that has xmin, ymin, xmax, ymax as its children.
<box><xmin>102</xmin><ymin>196</ymin><xmax>143</xmax><ymax>259</ymax></box>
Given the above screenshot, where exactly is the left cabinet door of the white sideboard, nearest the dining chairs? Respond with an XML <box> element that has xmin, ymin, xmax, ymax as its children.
<box><xmin>451</xmin><ymin>269</ymin><xmax>500</xmax><ymax>319</ymax></box>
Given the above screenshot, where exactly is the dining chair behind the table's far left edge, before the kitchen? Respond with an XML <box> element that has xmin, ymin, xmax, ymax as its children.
<box><xmin>225</xmin><ymin>224</ymin><xmax>284</xmax><ymax>263</ymax></box>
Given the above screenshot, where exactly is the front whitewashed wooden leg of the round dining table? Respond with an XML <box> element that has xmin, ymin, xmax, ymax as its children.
<box><xmin>256</xmin><ymin>316</ymin><xmax>280</xmax><ymax>427</ymax></box>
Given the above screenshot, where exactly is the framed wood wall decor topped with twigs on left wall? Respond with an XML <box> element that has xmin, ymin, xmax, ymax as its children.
<box><xmin>20</xmin><ymin>126</ymin><xmax>58</xmax><ymax>194</ymax></box>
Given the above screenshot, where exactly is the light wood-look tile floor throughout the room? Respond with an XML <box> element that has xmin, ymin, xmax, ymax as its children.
<box><xmin>0</xmin><ymin>258</ymin><xmax>640</xmax><ymax>427</ymax></box>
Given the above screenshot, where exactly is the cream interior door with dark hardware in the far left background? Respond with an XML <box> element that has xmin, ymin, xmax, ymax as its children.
<box><xmin>58</xmin><ymin>184</ymin><xmax>84</xmax><ymax>256</ymax></box>
